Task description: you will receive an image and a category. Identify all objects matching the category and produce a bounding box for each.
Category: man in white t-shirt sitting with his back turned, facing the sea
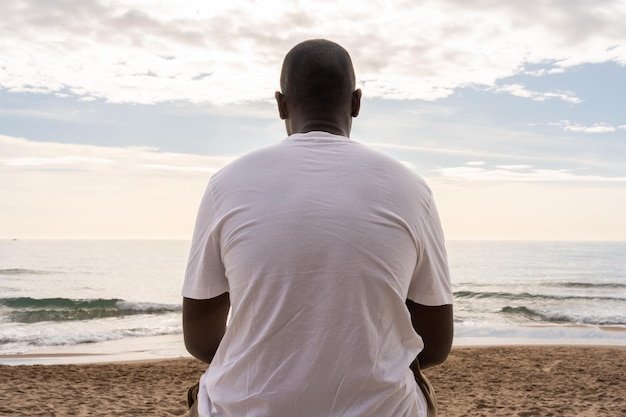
[183,40,452,417]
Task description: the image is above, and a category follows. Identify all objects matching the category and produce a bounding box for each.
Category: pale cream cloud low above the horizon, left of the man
[0,135,233,238]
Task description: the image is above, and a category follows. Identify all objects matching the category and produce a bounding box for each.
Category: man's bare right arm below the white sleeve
[406,300,454,369]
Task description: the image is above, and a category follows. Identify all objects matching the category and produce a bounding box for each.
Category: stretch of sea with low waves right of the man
[448,241,626,344]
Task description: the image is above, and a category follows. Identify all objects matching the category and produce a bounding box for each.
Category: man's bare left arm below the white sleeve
[183,293,230,363]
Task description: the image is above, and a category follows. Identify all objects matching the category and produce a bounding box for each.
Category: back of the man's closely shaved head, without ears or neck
[280,39,355,112]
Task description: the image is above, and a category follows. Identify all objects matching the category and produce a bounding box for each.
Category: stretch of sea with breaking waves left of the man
[0,239,189,363]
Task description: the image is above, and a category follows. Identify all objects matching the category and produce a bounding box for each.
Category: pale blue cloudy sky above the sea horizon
[0,0,626,240]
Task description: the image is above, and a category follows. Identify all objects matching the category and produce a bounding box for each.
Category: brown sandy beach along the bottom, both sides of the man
[0,346,626,417]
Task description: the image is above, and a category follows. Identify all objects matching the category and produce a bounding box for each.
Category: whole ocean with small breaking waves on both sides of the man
[0,239,626,364]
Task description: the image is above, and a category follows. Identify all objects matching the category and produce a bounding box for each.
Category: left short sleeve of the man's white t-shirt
[182,185,229,300]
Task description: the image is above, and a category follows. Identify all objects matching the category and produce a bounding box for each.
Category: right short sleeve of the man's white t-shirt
[407,201,453,306]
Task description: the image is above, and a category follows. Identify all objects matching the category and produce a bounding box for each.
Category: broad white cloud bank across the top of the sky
[0,0,626,104]
